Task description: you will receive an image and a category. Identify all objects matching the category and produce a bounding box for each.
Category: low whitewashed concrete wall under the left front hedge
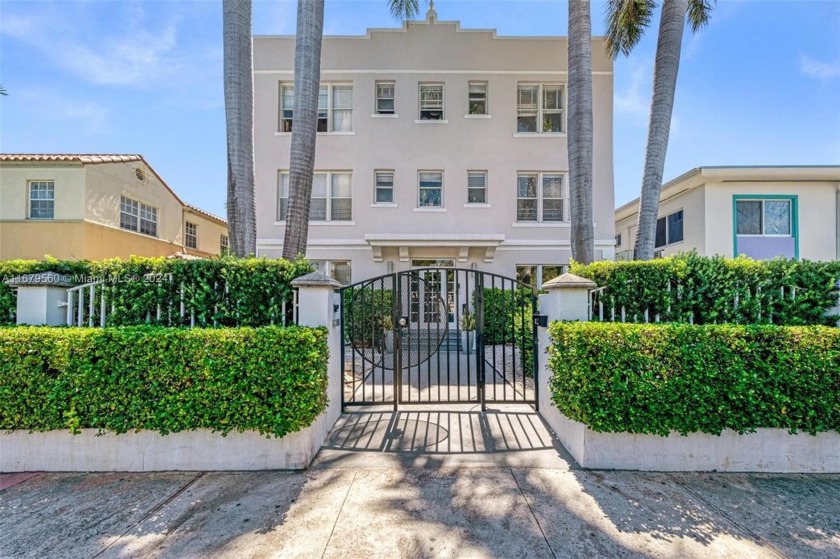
[0,406,338,472]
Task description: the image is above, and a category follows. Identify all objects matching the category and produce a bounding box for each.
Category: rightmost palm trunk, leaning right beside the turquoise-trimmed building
[634,0,688,260]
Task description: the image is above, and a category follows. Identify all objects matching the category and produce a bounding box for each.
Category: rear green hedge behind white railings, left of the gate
[0,257,312,326]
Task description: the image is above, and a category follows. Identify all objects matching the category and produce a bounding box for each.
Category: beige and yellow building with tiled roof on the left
[0,154,228,260]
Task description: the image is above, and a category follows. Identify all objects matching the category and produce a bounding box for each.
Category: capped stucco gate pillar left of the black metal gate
[292,272,344,424]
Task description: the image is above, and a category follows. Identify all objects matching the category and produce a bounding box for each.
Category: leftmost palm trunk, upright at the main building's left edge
[222,0,257,257]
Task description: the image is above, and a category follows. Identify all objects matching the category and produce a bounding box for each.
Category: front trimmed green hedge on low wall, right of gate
[549,322,840,436]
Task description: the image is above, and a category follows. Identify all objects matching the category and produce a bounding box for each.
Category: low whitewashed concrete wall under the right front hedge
[539,328,840,473]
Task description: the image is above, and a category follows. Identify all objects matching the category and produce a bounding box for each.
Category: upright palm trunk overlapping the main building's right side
[568,0,595,264]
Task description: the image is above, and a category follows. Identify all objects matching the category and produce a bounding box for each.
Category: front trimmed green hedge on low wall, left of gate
[0,326,327,437]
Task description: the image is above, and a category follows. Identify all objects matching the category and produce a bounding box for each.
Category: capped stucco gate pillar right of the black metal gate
[537,274,598,434]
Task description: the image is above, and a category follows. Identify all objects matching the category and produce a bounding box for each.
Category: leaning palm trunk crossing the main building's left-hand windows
[283,0,324,258]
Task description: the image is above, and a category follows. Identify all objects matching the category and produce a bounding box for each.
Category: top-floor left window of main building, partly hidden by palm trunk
[280,83,353,132]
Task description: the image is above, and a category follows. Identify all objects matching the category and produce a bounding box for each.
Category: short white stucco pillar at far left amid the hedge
[6,272,73,326]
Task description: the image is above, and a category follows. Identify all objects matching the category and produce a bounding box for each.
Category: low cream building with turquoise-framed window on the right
[615,166,840,260]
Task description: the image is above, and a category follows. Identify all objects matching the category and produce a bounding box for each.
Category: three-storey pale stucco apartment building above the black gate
[254,11,614,283]
